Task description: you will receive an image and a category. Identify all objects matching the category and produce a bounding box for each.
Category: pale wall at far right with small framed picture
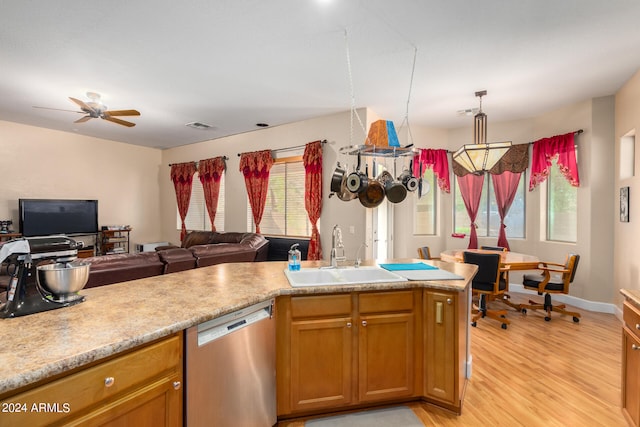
[611,71,640,307]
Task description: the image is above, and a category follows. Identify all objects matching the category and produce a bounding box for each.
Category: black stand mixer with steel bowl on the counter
[0,236,90,318]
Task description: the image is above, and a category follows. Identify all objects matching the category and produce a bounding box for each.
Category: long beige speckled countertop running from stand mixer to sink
[0,259,476,394]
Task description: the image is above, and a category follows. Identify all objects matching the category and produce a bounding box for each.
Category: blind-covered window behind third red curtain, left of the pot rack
[247,157,311,237]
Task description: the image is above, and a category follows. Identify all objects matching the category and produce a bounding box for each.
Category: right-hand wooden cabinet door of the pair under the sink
[358,313,415,402]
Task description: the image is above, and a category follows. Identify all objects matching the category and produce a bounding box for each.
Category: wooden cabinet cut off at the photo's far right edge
[622,301,640,426]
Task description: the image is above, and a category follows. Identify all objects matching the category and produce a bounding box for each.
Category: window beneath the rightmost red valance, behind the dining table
[547,161,578,243]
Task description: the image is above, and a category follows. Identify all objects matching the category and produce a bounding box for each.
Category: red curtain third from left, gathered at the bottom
[240,150,273,233]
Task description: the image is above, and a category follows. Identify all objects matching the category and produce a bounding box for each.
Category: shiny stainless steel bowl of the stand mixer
[37,261,91,296]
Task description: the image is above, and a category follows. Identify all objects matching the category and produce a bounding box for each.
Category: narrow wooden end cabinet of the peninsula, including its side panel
[423,290,468,413]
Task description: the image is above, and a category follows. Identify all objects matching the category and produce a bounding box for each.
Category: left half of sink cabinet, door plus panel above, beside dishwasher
[276,294,354,413]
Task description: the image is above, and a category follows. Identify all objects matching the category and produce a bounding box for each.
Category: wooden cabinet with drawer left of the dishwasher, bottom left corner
[0,333,183,427]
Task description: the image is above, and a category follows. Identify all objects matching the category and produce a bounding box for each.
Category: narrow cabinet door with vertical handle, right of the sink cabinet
[424,291,458,404]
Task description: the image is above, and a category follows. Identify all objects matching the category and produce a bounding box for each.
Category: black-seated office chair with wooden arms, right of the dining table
[520,254,580,323]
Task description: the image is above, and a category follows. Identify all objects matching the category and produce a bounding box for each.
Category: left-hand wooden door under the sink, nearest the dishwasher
[291,317,353,411]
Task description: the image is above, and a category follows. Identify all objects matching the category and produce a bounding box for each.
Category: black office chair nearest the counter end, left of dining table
[463,252,511,329]
